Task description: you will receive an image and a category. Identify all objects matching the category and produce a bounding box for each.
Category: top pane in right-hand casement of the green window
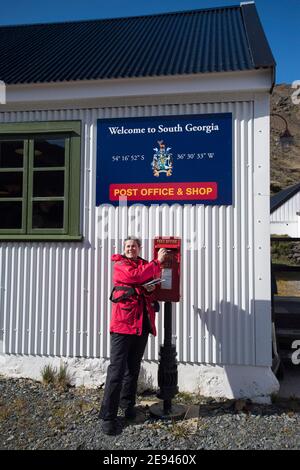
[34,139,65,167]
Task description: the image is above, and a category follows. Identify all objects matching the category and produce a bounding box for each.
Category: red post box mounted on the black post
[154,237,181,302]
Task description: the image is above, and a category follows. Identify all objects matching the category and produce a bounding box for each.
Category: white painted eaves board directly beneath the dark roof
[0,69,272,111]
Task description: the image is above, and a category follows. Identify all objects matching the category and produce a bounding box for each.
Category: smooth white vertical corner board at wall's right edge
[253,95,272,366]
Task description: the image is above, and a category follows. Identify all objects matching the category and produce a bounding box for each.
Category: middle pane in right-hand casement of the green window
[33,171,65,197]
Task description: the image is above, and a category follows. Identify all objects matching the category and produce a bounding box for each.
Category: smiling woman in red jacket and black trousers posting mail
[100,237,167,435]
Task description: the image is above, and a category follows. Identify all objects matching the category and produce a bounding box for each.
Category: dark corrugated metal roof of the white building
[0,5,275,84]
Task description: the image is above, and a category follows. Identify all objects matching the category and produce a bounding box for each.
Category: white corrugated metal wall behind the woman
[0,102,255,364]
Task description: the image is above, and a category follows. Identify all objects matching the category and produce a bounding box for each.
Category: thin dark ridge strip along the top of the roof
[0,5,240,29]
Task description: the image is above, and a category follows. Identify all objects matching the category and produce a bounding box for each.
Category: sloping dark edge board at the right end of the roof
[240,2,276,89]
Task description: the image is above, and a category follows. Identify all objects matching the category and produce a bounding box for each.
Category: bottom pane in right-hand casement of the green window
[32,201,64,228]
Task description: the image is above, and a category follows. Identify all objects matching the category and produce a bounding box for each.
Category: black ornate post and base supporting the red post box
[150,302,186,419]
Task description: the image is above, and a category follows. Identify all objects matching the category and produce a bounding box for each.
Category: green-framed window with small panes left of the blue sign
[0,121,81,240]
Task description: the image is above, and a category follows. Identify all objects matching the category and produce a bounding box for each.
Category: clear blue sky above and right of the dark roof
[0,0,300,83]
